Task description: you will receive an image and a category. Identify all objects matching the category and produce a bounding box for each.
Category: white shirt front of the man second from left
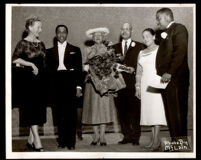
[57,41,67,71]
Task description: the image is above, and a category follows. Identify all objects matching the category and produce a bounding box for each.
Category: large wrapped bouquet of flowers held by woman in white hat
[86,43,133,95]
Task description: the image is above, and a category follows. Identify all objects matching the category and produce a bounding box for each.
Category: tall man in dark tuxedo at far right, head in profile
[156,8,189,137]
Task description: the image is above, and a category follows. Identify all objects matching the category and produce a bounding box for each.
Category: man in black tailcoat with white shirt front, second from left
[46,25,82,150]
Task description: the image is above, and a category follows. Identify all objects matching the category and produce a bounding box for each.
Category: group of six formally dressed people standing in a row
[12,8,189,151]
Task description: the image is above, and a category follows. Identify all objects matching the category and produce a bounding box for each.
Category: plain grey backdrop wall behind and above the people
[11,6,194,128]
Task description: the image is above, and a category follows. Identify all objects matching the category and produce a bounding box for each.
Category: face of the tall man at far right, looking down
[156,12,170,29]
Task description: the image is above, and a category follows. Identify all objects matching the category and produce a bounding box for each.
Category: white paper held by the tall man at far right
[149,75,169,89]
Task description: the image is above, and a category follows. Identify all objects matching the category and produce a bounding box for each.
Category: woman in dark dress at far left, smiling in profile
[12,17,46,152]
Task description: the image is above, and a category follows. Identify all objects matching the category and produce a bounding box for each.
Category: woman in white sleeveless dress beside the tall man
[135,28,167,151]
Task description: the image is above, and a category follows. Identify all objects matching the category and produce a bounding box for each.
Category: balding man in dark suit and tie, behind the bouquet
[113,23,144,145]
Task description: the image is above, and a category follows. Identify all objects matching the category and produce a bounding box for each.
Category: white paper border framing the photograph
[5,3,196,159]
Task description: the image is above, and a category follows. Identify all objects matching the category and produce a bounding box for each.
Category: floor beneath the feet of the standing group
[12,131,192,152]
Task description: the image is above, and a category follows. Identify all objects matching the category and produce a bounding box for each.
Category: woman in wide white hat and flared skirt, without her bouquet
[82,28,117,146]
